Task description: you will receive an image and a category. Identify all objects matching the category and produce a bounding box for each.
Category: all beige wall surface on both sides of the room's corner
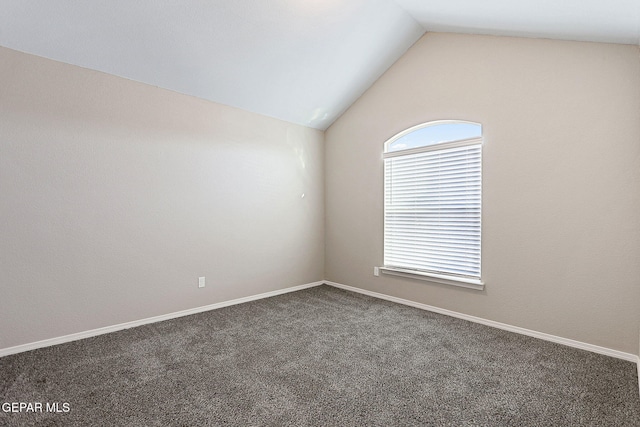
[0,34,640,354]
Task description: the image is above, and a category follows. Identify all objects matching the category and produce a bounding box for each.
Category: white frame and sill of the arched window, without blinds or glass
[380,120,484,290]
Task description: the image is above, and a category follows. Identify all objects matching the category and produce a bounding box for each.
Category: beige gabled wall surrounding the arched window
[325,33,640,354]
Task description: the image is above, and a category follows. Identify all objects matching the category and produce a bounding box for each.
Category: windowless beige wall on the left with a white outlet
[0,48,324,348]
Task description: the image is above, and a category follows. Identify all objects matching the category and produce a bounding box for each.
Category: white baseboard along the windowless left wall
[0,281,325,357]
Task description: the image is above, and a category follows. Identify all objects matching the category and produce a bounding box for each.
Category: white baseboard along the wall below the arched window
[324,280,640,364]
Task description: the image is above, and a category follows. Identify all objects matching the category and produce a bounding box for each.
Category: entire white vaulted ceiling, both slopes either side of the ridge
[0,0,640,129]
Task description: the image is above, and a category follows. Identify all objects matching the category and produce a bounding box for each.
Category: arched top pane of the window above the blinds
[384,120,482,153]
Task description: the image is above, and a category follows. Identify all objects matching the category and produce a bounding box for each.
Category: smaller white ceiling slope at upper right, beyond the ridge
[396,0,640,44]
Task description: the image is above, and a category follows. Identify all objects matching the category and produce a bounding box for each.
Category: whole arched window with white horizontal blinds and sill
[383,120,483,288]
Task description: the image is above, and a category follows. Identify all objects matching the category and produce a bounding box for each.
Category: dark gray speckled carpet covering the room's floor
[0,286,640,426]
